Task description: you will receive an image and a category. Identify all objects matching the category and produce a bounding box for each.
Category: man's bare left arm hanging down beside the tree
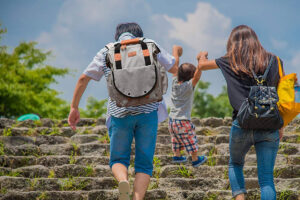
[68,74,91,130]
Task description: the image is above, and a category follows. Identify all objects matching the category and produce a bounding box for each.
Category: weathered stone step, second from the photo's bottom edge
[0,176,300,192]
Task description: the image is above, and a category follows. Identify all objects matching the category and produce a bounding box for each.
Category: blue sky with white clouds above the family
[0,0,300,107]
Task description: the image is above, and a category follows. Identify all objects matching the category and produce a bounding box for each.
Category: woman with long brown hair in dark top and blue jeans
[197,25,283,200]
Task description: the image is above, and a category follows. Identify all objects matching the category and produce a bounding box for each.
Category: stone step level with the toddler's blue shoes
[0,154,300,169]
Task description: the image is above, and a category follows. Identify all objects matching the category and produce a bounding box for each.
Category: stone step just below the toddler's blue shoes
[0,164,300,179]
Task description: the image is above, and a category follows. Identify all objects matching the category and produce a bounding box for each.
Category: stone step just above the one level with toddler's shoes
[3,142,300,156]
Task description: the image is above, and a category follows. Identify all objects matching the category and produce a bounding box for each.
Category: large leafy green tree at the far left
[0,24,69,118]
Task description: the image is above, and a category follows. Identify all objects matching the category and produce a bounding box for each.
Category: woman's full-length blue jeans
[228,120,279,200]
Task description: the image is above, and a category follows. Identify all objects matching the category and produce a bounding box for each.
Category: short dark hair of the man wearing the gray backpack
[115,22,144,41]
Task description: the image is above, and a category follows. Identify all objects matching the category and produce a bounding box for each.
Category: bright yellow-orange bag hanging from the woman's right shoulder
[277,56,300,126]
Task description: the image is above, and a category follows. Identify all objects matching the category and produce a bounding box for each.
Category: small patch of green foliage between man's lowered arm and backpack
[80,97,107,118]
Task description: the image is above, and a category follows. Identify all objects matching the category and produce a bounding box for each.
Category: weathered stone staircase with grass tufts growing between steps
[0,118,300,200]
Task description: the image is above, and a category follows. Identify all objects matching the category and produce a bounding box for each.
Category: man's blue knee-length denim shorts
[109,111,158,176]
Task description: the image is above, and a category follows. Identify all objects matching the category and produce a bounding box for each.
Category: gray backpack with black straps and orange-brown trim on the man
[106,38,168,107]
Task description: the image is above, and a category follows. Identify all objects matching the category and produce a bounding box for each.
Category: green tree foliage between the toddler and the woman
[192,81,232,118]
